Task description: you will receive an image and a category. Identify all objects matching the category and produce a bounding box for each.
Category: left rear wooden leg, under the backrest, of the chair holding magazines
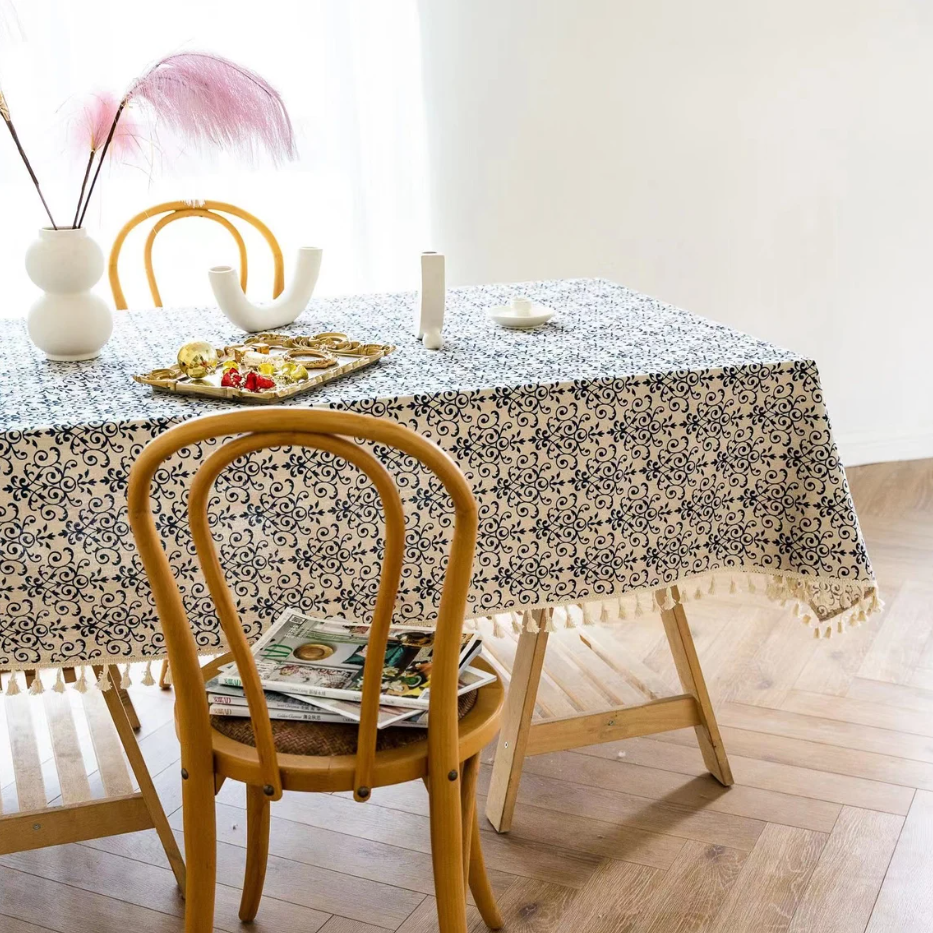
[181,759,217,933]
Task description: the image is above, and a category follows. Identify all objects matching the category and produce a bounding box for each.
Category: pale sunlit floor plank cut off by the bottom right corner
[866,791,933,933]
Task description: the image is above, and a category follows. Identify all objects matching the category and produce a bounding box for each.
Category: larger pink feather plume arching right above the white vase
[123,52,296,162]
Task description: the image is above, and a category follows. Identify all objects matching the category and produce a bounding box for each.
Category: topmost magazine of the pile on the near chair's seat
[212,609,495,727]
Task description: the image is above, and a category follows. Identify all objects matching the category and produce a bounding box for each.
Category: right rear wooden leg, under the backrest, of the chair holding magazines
[427,772,467,933]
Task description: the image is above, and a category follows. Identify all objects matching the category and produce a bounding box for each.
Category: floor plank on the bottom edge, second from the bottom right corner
[789,807,904,933]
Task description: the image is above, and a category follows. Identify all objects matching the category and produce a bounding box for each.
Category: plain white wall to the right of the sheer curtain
[420,0,933,465]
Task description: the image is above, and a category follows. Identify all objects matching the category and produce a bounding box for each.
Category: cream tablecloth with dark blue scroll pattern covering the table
[0,280,874,668]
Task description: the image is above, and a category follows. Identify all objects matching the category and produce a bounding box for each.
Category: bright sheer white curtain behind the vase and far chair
[0,0,431,317]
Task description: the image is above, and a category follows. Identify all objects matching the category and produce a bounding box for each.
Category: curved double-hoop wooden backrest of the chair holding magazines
[128,408,477,800]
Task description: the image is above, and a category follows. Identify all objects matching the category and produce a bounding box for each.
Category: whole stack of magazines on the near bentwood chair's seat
[207,609,495,729]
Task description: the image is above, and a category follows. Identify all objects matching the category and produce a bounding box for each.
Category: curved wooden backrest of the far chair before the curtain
[108,201,285,311]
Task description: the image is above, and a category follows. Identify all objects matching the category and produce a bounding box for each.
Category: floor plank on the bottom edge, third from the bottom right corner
[708,824,827,933]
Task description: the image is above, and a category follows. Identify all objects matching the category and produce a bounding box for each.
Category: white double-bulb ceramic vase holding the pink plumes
[26,227,113,360]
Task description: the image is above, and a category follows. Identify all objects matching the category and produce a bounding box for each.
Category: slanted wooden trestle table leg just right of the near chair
[486,609,551,833]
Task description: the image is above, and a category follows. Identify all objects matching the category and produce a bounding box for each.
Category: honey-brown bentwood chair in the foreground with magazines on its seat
[128,408,503,933]
